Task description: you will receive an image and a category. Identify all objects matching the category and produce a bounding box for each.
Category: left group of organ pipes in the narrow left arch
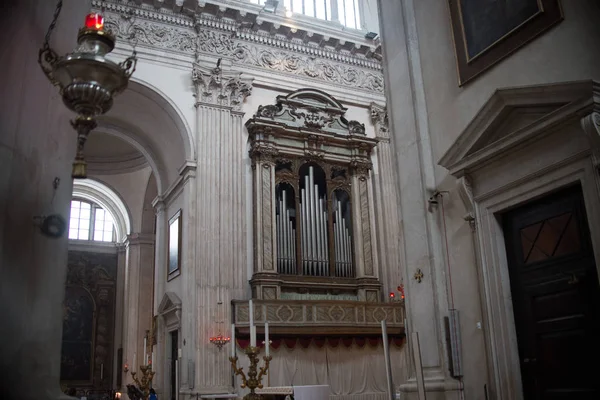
[275,189,298,275]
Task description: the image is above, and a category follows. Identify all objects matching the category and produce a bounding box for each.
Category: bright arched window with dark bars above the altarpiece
[69,199,116,242]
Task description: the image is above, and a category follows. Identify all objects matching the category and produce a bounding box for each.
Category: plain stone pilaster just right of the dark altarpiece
[123,233,154,386]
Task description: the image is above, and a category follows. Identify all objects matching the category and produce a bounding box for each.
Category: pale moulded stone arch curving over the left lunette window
[73,178,131,243]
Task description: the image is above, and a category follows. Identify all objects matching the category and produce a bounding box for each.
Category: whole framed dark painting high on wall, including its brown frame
[448,0,563,86]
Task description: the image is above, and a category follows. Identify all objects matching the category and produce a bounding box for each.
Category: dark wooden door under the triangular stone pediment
[503,186,600,400]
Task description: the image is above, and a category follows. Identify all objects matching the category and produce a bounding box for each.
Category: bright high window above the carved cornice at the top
[250,0,361,29]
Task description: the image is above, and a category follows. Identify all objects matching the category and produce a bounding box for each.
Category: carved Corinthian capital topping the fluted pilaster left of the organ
[192,63,253,111]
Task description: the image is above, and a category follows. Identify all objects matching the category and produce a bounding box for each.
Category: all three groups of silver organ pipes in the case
[275,166,354,278]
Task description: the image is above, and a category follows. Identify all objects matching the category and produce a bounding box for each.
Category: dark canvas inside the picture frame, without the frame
[460,0,541,59]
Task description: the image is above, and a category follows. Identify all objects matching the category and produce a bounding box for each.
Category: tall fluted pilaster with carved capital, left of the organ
[192,61,252,398]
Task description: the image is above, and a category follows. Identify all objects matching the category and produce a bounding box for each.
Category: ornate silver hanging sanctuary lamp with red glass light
[38,0,137,179]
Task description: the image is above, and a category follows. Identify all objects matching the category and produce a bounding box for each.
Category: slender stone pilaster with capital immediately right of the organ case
[370,103,404,294]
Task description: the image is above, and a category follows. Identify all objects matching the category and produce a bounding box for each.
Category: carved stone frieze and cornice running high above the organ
[92,1,384,95]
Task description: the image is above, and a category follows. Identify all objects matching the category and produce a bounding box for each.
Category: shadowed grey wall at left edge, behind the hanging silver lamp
[0,0,90,400]
